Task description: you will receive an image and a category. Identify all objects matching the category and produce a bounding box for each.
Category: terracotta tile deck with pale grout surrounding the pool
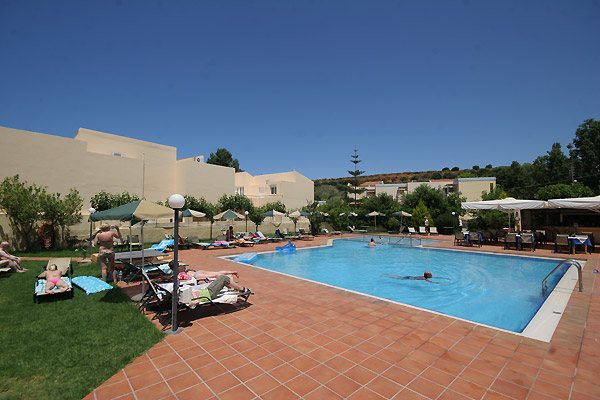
[86,236,600,400]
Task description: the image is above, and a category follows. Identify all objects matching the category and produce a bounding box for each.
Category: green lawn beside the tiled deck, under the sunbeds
[0,258,164,399]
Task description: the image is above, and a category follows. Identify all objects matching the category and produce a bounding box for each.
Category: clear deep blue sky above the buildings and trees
[0,0,600,179]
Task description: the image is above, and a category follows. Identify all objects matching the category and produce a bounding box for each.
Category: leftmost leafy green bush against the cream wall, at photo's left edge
[0,175,45,250]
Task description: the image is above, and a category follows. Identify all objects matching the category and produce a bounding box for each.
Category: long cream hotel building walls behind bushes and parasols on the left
[0,127,314,240]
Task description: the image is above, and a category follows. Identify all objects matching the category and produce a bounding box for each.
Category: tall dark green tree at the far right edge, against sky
[569,119,600,191]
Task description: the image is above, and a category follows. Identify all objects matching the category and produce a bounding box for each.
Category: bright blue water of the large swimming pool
[232,240,568,332]
